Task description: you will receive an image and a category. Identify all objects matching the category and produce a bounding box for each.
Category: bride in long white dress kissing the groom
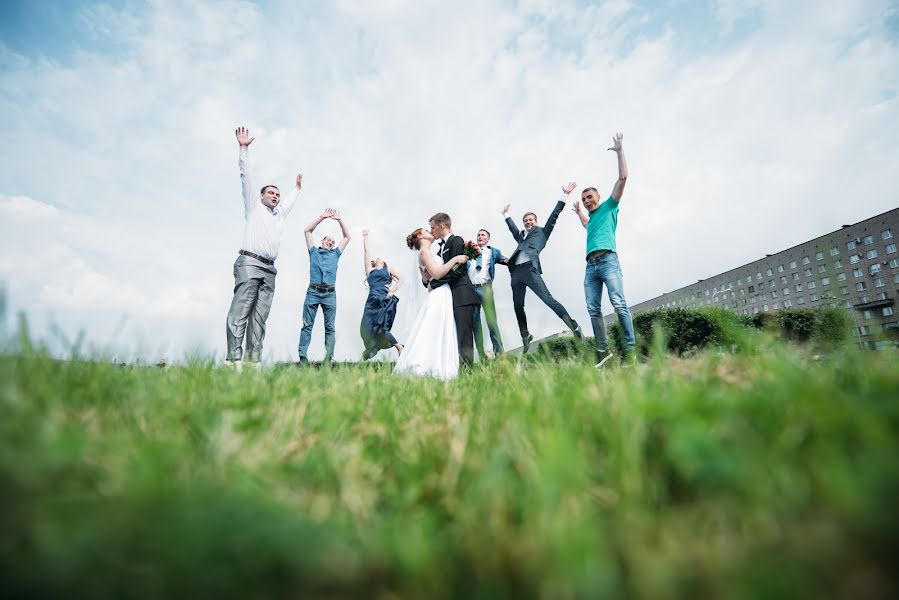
[393,227,468,380]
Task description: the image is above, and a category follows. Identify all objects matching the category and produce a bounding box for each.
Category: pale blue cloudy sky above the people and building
[0,0,899,362]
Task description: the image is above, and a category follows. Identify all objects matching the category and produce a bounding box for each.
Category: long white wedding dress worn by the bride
[393,255,459,381]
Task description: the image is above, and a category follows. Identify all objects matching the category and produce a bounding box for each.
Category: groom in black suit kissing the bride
[428,213,481,366]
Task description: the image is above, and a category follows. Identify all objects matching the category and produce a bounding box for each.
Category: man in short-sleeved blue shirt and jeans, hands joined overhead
[298,208,350,364]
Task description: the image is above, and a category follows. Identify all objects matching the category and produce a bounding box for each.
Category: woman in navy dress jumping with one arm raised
[359,229,403,360]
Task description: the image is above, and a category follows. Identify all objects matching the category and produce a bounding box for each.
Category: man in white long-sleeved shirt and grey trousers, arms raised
[226,127,303,367]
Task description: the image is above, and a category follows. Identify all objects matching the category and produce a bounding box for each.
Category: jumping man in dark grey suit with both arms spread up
[503,181,584,352]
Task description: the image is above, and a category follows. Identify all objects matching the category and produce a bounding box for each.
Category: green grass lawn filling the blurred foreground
[0,342,899,599]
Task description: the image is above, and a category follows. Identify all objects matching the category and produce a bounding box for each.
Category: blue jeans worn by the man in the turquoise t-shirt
[584,252,635,352]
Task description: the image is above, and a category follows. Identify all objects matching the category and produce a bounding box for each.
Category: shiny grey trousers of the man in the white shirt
[225,254,278,362]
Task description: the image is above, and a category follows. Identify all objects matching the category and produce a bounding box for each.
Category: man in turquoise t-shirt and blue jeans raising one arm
[572,133,635,369]
